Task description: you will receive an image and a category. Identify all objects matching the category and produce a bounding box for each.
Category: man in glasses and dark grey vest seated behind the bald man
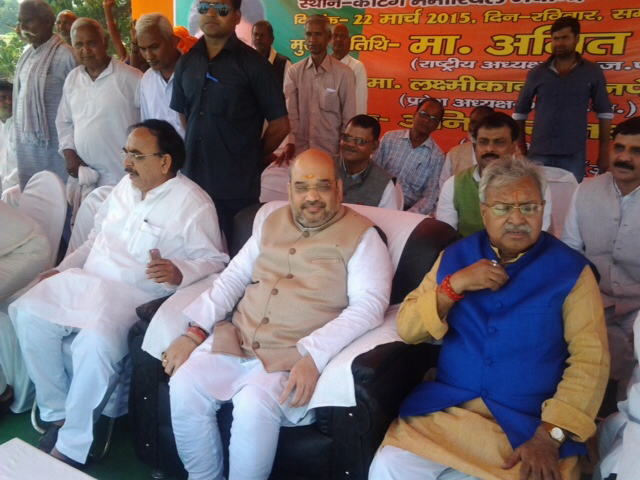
[338,115,404,210]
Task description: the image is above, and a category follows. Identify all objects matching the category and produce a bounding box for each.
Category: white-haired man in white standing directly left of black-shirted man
[136,13,184,138]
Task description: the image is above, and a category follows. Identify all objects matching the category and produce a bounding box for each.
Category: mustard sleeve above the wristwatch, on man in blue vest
[542,266,609,442]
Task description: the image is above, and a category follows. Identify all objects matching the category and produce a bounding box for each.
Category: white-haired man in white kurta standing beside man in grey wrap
[56,18,142,191]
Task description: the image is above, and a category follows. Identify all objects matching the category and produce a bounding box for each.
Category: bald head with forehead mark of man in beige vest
[289,149,342,228]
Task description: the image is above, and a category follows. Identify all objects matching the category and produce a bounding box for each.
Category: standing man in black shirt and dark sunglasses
[171,0,289,241]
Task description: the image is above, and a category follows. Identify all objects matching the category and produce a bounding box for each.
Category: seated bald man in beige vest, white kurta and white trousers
[163,150,392,480]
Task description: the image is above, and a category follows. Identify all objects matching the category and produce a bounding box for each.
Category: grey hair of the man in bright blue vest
[478,155,547,203]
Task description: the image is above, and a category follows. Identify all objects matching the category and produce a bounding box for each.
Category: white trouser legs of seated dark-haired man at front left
[14,311,124,463]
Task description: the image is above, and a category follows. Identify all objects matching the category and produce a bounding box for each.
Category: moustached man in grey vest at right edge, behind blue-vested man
[562,117,640,400]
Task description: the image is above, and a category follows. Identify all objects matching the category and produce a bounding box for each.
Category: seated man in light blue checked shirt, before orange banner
[373,98,444,215]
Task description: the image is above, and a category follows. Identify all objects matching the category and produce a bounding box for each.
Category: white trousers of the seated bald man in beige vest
[169,339,296,480]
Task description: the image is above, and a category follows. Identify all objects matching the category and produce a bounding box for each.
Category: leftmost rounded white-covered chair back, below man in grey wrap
[18,170,67,268]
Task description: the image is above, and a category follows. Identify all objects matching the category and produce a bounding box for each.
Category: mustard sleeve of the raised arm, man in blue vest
[396,252,449,343]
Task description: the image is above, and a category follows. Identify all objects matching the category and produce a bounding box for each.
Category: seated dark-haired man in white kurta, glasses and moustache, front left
[9,120,228,465]
